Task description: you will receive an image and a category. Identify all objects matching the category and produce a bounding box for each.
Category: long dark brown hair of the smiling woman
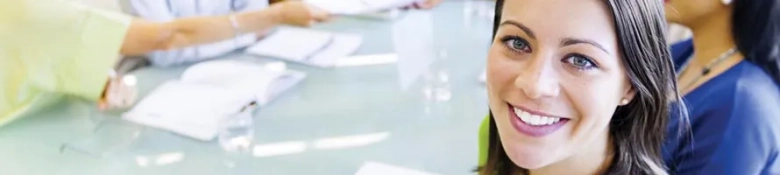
[480,0,687,175]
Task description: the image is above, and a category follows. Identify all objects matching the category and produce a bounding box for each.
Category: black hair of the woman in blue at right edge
[731,0,780,83]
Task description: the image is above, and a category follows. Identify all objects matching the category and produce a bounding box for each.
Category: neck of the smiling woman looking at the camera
[529,133,615,175]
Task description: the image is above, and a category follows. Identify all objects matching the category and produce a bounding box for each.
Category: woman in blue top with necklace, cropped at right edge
[663,0,780,175]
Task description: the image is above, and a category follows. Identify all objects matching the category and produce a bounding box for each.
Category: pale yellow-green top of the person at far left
[0,0,131,126]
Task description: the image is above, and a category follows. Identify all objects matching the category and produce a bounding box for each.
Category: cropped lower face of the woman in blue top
[664,0,727,26]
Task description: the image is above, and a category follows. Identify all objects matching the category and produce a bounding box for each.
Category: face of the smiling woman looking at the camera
[487,0,633,169]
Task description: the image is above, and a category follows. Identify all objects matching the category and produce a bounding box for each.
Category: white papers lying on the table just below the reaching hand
[245,27,363,67]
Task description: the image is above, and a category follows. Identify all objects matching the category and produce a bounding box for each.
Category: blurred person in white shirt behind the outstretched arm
[129,0,328,66]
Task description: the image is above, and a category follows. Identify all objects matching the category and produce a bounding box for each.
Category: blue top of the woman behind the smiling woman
[663,40,780,175]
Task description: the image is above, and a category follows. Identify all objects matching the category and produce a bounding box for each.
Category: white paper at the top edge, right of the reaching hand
[304,0,421,15]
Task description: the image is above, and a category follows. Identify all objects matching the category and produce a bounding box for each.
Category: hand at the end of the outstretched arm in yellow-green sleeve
[271,1,330,26]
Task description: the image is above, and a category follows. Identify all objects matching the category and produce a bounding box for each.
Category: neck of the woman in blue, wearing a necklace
[686,7,736,66]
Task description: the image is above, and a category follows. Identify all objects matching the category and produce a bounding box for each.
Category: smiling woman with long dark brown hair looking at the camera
[481,0,685,175]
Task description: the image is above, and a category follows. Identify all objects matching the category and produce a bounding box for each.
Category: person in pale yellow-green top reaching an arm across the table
[0,0,326,125]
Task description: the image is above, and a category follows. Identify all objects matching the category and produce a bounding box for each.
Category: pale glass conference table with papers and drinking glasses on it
[0,1,493,175]
